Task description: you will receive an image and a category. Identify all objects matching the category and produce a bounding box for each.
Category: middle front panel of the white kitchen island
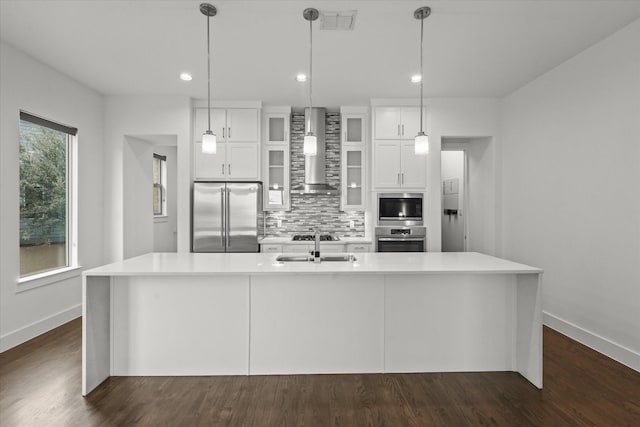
[250,274,384,375]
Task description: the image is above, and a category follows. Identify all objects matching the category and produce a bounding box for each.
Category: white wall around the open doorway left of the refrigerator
[104,95,192,262]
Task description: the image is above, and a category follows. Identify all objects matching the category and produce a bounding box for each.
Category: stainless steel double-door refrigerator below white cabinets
[191,182,263,252]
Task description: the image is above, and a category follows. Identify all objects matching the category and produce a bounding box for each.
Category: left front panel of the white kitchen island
[113,275,250,376]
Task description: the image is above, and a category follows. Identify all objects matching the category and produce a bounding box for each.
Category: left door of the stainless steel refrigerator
[192,182,225,252]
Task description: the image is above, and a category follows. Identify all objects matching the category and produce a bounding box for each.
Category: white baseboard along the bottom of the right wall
[542,311,640,372]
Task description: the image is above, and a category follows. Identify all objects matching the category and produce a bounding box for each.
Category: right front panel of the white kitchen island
[385,274,515,372]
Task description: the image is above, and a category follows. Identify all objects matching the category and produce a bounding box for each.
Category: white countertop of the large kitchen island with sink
[83,252,542,276]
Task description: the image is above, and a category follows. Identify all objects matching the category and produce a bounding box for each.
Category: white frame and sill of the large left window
[16,110,82,292]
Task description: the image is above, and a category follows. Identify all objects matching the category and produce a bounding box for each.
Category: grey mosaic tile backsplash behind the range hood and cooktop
[265,112,364,237]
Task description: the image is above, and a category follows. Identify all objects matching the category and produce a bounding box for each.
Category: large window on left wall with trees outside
[20,111,78,278]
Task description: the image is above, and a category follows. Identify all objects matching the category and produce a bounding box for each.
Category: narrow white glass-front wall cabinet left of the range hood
[262,107,291,210]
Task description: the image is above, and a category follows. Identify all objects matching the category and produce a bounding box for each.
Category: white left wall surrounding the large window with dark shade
[0,43,104,351]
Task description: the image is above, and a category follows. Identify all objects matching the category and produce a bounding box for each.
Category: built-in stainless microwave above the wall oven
[378,193,424,226]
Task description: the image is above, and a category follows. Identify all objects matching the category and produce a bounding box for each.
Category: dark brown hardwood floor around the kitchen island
[0,319,640,427]
